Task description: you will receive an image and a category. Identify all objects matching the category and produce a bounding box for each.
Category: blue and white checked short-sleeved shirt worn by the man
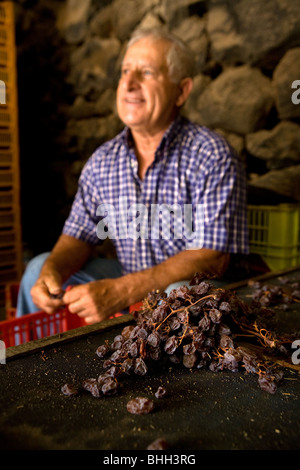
[63,117,248,273]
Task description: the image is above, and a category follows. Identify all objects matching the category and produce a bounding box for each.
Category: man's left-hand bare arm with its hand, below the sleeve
[31,235,92,313]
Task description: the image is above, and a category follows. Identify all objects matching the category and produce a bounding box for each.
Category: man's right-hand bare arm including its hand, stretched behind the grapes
[63,248,230,323]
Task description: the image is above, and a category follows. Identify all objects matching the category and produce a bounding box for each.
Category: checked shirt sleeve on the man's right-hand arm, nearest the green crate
[189,133,249,254]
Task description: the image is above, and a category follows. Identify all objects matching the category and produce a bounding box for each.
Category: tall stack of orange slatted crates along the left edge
[0,1,22,307]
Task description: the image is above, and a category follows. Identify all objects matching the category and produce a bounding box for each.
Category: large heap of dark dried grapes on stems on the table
[63,274,293,397]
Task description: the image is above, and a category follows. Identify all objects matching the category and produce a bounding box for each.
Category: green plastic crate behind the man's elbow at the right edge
[248,204,300,271]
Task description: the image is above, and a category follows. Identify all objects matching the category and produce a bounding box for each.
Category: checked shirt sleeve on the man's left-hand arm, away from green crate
[63,160,101,245]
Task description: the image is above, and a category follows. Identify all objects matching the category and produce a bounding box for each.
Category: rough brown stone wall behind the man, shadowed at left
[16,0,300,252]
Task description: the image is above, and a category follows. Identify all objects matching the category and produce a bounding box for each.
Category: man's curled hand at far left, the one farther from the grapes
[31,274,64,313]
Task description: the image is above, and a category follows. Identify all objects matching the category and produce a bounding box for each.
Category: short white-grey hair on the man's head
[126,28,195,83]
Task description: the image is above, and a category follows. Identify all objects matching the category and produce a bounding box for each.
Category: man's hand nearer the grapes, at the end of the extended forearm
[63,278,128,324]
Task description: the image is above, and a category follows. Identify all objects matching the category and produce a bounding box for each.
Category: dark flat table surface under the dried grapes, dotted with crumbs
[0,270,300,452]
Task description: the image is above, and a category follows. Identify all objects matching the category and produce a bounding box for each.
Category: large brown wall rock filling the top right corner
[208,0,300,69]
